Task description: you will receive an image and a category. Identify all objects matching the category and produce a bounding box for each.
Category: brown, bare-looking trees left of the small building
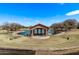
[0,23,25,32]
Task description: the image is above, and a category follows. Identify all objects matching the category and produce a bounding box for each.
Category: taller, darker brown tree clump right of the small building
[50,19,79,34]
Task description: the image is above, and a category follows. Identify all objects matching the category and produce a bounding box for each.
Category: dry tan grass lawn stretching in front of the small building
[0,30,79,50]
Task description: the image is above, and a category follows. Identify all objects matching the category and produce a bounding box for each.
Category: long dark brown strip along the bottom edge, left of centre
[0,50,35,55]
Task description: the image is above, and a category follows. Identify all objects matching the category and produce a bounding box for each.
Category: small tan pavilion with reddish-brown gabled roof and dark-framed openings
[30,24,49,36]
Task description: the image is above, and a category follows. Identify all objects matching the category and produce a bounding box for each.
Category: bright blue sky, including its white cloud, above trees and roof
[0,3,79,26]
